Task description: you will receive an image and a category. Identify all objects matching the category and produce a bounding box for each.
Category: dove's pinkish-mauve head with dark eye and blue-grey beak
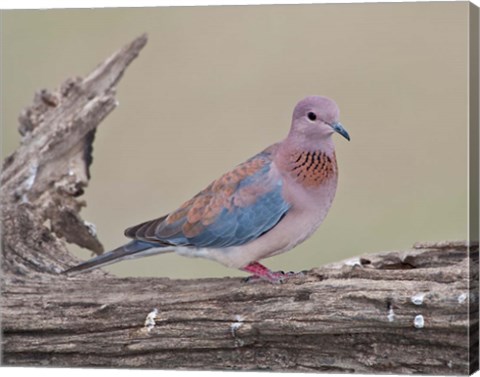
[290,96,350,143]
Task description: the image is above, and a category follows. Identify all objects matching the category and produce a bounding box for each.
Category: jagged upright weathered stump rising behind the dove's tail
[1,35,147,273]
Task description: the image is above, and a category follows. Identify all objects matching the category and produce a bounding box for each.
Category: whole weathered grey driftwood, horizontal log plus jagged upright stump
[1,36,478,374]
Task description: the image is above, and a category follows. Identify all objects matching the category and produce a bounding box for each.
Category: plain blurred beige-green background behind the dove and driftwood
[1,2,468,278]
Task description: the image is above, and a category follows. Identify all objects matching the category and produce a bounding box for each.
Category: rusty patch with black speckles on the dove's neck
[290,151,337,187]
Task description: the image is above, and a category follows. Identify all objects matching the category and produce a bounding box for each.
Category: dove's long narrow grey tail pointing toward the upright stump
[62,240,173,274]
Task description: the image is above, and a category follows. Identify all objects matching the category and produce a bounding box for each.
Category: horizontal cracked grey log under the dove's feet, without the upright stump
[2,239,478,374]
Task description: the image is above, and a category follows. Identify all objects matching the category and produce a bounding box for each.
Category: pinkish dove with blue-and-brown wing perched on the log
[64,96,350,283]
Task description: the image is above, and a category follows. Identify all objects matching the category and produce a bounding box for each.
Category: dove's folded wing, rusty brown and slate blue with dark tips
[125,145,290,248]
